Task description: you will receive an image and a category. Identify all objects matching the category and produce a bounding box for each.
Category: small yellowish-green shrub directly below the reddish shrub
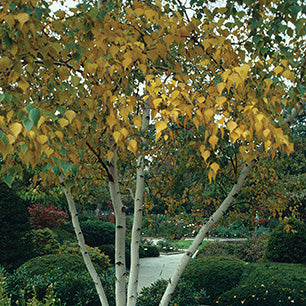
[28,228,60,257]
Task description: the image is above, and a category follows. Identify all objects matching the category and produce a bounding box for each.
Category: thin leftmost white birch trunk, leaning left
[60,176,109,306]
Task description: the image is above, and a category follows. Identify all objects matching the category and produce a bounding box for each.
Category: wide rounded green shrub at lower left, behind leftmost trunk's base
[7,254,114,305]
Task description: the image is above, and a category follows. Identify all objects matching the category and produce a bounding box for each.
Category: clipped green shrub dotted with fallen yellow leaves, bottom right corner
[218,263,306,306]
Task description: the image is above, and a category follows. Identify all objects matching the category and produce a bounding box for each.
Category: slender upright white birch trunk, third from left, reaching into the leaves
[127,101,150,306]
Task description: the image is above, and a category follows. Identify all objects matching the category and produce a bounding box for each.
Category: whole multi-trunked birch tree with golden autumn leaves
[0,0,305,306]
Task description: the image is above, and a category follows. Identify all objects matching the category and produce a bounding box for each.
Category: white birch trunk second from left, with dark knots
[109,149,126,306]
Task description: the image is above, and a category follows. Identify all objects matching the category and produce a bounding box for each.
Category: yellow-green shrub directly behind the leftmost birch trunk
[57,241,110,271]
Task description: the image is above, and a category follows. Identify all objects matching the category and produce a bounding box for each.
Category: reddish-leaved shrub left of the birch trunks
[28,203,67,229]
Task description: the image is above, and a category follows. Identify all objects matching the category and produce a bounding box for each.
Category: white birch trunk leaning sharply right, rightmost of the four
[159,161,254,306]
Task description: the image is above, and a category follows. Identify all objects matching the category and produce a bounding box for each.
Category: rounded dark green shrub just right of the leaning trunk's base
[182,256,246,301]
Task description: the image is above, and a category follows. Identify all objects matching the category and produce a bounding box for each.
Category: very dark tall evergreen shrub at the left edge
[0,182,31,270]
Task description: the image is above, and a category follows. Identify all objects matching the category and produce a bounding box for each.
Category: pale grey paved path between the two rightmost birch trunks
[137,254,183,292]
